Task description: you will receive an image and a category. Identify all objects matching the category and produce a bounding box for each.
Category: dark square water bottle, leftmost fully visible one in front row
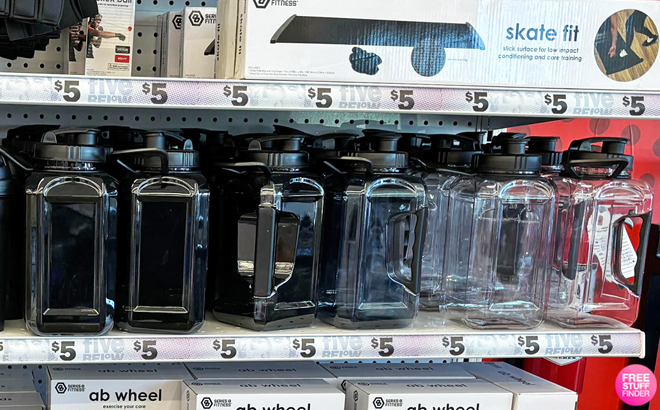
[25,129,117,336]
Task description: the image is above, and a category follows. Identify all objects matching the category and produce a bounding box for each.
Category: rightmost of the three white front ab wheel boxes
[344,379,512,410]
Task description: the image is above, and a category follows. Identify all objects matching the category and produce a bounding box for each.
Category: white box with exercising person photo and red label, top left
[85,0,135,77]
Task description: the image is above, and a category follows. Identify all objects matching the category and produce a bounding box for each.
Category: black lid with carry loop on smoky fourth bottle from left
[344,130,408,169]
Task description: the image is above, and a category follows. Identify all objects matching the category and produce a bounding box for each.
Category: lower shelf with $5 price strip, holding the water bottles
[0,313,644,364]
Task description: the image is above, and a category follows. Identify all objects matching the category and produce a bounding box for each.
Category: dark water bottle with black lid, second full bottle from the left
[113,131,209,333]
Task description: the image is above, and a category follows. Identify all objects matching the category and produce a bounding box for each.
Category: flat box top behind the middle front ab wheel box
[186,362,335,382]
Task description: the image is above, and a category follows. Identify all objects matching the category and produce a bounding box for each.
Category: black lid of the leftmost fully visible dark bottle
[34,128,107,164]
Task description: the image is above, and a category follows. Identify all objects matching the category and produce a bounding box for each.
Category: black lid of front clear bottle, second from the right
[473,133,541,174]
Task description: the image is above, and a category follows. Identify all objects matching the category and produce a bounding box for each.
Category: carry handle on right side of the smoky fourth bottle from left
[388,208,427,294]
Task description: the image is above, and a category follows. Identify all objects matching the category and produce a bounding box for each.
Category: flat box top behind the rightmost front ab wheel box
[321,363,475,390]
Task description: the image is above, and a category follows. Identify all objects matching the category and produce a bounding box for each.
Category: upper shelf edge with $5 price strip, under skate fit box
[0,74,660,119]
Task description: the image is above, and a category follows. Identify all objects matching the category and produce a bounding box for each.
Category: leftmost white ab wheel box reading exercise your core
[48,363,190,410]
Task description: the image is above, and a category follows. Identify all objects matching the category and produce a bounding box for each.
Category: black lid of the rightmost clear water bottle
[564,137,633,171]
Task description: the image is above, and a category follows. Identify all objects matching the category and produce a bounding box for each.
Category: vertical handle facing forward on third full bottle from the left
[254,204,277,298]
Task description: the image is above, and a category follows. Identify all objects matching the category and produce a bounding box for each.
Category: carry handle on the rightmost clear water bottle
[612,212,652,296]
